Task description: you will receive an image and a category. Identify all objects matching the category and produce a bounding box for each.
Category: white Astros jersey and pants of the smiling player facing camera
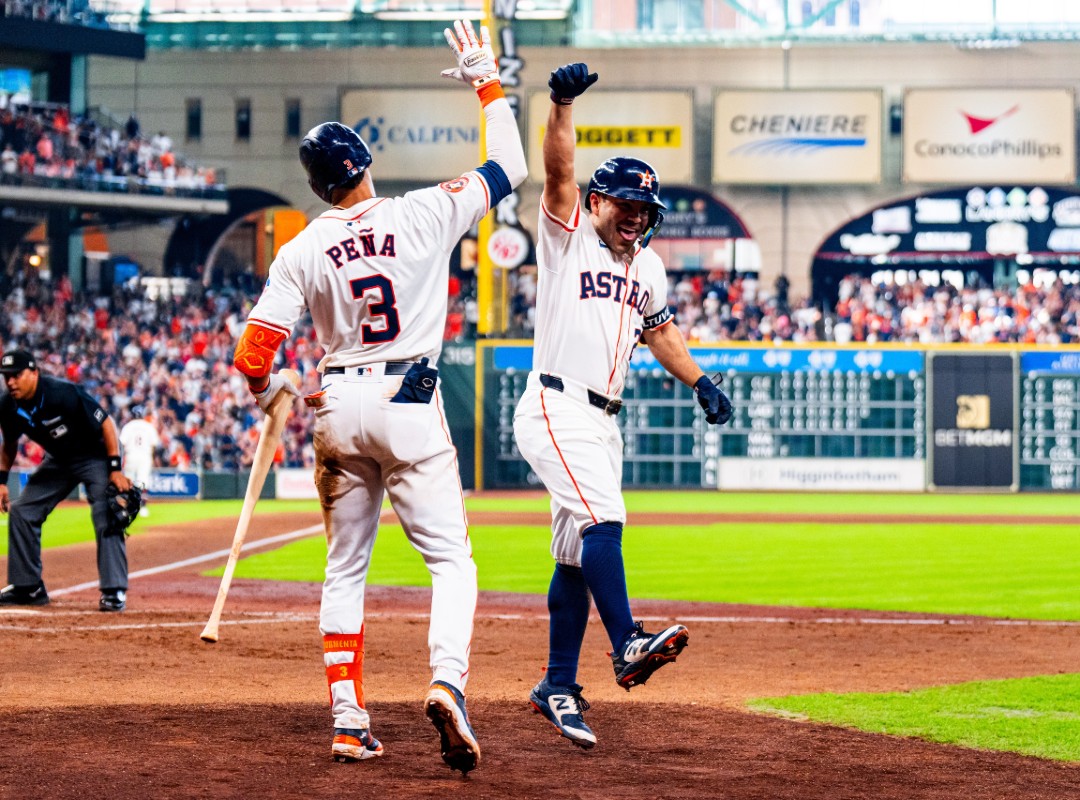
[514,198,672,567]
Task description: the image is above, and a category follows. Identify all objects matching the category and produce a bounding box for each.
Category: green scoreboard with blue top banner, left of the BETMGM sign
[483,344,927,488]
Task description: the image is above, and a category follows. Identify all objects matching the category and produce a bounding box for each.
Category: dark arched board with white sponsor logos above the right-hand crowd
[810,185,1080,308]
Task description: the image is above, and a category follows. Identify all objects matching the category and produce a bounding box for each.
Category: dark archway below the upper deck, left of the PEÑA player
[164,188,289,289]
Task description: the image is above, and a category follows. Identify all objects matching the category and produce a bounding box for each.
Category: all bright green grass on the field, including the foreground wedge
[14,485,1080,761]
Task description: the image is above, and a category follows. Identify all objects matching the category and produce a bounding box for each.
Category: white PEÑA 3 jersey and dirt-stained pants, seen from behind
[241,93,526,729]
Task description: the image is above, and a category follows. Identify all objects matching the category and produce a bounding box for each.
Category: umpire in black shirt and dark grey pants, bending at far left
[0,350,138,611]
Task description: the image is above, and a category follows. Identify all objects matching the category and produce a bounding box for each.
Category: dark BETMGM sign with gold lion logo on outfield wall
[927,352,1020,491]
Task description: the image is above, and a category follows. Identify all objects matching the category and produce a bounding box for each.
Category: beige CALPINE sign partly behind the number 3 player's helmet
[340,87,480,181]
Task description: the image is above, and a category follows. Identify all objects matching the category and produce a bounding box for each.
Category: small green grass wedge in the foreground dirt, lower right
[750,675,1080,761]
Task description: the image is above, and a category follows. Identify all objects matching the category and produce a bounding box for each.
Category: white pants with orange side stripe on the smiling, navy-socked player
[514,374,626,567]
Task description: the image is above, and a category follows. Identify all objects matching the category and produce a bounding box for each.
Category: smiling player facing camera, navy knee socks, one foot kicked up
[514,64,731,748]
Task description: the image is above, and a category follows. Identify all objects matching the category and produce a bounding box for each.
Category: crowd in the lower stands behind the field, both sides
[0,262,1080,470]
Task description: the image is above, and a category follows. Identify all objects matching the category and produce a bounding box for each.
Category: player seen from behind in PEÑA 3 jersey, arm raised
[234,21,527,773]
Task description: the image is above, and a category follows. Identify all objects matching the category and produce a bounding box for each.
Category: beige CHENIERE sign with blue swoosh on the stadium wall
[713,91,882,185]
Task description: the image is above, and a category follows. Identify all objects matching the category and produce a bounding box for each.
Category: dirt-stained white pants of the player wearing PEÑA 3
[314,364,476,728]
